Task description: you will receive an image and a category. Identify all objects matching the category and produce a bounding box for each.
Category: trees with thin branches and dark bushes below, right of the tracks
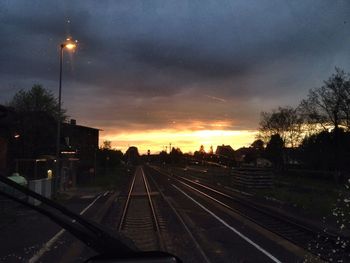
[259,68,350,171]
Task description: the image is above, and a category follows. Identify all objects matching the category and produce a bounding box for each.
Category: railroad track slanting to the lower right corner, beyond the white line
[151,167,350,262]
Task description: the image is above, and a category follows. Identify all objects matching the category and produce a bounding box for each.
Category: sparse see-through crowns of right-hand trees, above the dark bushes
[259,68,350,147]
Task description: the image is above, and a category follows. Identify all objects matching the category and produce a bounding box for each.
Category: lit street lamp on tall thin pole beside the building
[55,38,78,194]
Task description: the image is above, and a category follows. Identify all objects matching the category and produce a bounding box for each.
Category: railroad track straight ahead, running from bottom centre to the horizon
[118,166,164,251]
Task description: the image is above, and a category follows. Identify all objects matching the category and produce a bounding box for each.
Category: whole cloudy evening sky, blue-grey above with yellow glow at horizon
[0,0,350,152]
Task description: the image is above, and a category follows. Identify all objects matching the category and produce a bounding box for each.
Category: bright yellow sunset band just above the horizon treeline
[100,129,257,154]
